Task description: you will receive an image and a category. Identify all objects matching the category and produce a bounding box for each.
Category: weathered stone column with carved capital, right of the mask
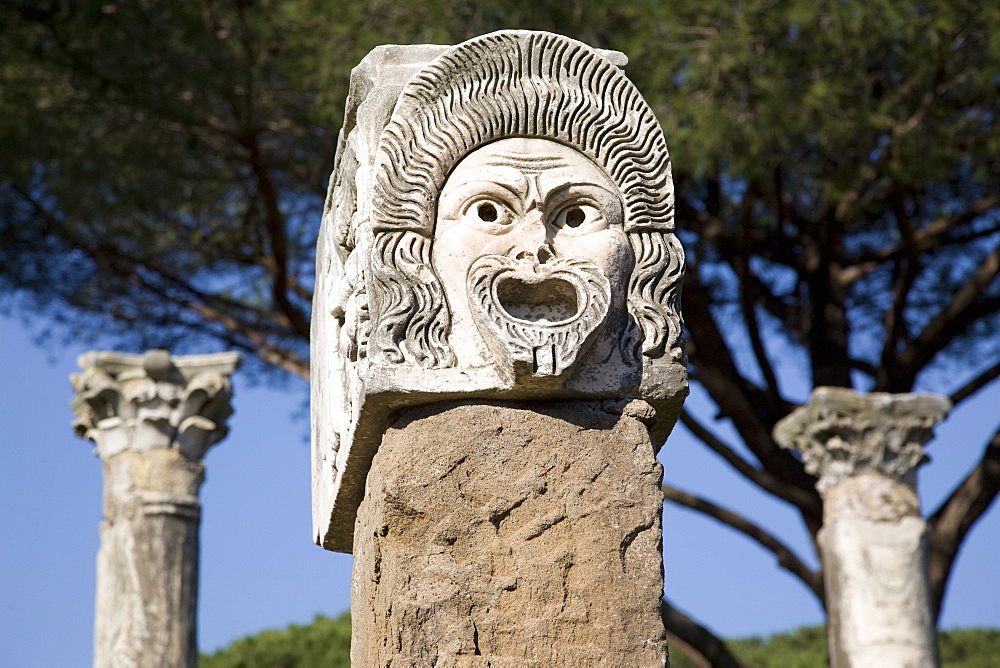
[774,387,951,668]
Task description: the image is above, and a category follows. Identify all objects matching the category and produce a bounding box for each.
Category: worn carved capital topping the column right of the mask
[774,387,951,493]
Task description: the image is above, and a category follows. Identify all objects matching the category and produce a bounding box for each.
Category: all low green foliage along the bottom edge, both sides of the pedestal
[201,612,1000,668]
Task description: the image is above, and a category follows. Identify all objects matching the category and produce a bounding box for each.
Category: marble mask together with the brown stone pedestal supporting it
[312,31,687,666]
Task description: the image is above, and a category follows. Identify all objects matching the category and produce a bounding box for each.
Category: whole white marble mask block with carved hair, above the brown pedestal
[312,31,687,551]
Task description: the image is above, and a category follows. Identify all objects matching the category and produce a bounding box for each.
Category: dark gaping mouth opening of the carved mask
[495,275,580,325]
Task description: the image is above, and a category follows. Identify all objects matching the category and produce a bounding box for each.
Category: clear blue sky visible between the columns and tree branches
[0,317,1000,668]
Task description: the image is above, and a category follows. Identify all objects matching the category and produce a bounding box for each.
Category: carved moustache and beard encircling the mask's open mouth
[466,254,611,385]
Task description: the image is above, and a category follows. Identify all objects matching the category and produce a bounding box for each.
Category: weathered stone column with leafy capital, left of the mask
[71,350,240,668]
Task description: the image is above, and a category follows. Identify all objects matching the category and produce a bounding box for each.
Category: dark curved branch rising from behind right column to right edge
[928,429,1000,617]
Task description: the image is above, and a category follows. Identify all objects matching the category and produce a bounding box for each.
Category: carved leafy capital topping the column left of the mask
[70,350,241,460]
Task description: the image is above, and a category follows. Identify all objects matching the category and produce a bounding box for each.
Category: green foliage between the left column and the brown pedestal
[200,612,351,668]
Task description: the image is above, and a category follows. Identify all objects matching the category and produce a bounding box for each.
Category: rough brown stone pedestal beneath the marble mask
[351,401,666,666]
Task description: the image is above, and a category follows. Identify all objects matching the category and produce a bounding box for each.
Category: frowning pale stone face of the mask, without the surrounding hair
[431,138,634,385]
